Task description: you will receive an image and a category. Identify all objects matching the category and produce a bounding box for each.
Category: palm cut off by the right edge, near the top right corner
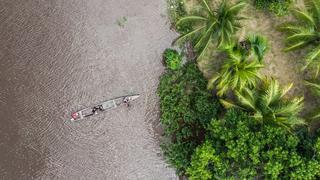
[280,0,320,76]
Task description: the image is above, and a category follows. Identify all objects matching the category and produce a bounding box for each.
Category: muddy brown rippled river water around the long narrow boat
[0,0,176,180]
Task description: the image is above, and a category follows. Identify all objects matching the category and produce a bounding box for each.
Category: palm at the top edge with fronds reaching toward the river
[174,0,246,58]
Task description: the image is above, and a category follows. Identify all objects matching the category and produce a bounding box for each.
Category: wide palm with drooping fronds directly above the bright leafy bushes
[221,78,305,129]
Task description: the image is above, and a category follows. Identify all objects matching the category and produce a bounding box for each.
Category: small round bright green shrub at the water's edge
[163,49,182,70]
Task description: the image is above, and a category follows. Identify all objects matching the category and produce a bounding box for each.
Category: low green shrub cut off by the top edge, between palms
[254,0,292,16]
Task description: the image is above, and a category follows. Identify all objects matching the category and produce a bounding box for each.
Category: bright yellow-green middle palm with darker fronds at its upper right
[208,35,267,96]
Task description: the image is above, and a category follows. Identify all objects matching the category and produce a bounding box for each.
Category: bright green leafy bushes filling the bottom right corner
[187,109,320,180]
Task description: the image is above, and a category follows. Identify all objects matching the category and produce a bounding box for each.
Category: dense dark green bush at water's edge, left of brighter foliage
[158,63,219,174]
